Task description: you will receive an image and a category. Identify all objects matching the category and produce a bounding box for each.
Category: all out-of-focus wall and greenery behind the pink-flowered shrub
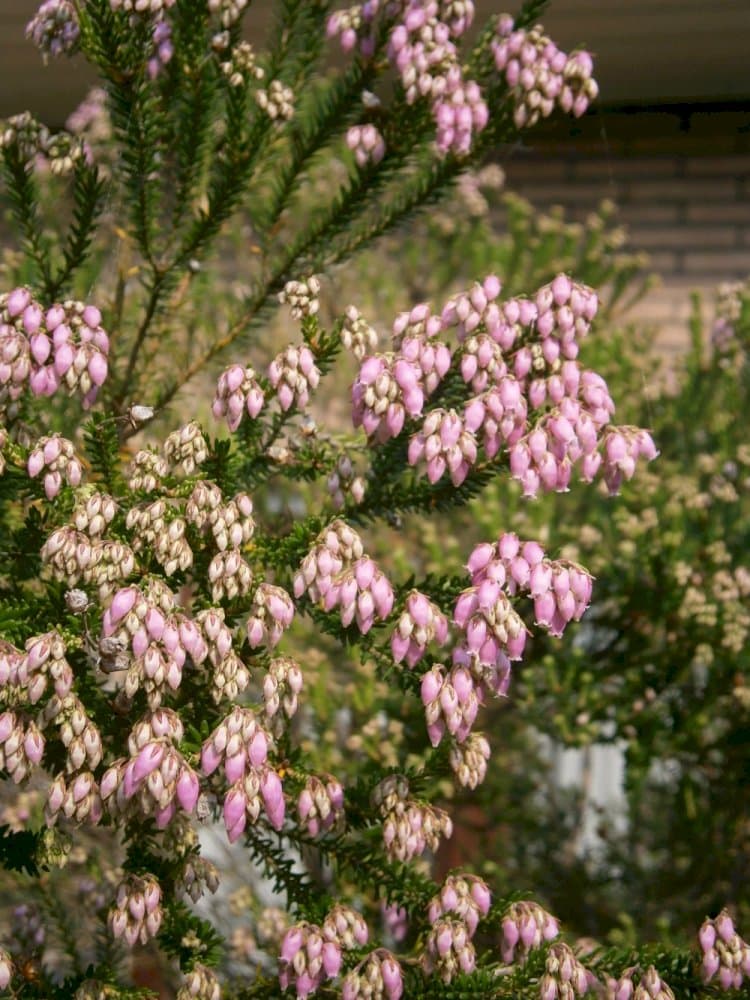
[0,0,750,997]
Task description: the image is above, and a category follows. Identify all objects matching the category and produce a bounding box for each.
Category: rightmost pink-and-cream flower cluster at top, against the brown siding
[492,14,599,128]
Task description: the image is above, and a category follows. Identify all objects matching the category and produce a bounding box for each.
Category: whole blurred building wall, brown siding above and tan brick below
[0,0,750,350]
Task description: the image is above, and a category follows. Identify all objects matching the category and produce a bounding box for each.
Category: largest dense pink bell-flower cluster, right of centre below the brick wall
[352,274,657,497]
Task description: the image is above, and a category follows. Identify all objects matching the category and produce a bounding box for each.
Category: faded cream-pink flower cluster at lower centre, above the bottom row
[372,775,453,861]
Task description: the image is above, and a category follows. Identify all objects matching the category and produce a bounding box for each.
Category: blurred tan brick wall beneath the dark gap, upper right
[504,106,750,349]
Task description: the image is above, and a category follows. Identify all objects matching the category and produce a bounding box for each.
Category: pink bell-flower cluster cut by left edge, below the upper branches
[0,287,109,407]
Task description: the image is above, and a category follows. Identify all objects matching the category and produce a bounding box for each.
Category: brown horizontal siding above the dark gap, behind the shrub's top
[0,0,750,124]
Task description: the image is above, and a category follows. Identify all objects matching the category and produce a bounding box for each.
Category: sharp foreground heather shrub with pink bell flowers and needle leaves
[0,0,748,1000]
